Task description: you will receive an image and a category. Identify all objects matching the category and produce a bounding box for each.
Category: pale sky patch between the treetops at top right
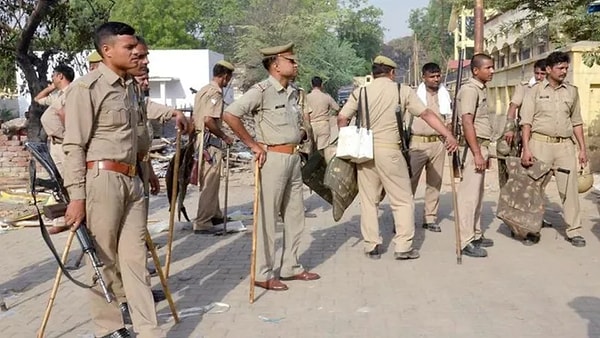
[368,0,429,42]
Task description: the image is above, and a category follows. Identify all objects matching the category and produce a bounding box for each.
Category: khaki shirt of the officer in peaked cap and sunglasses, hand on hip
[227,76,303,145]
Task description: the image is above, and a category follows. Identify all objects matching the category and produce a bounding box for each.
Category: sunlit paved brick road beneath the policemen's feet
[0,162,600,337]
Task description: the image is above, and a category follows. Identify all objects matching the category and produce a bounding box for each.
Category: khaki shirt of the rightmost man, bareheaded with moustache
[521,80,583,138]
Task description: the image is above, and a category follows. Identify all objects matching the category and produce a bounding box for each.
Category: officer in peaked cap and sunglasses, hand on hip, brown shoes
[223,43,320,291]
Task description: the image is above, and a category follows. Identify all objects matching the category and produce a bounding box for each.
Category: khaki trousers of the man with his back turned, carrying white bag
[356,147,415,252]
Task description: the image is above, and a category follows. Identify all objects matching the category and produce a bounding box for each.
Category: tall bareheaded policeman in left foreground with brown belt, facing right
[63,22,165,337]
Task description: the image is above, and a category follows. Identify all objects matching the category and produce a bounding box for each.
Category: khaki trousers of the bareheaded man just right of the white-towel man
[457,145,489,249]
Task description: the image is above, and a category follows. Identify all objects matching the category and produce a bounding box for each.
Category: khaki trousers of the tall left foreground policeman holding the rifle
[86,166,165,338]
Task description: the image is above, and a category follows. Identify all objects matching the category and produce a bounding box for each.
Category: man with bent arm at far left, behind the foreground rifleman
[34,65,75,173]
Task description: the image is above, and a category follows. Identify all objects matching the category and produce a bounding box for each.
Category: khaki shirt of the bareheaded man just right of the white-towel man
[456,78,493,140]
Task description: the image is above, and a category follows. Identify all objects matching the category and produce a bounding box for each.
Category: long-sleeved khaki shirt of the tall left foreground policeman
[63,63,143,200]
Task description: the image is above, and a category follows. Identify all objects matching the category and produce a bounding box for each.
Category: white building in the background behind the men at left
[17,49,233,116]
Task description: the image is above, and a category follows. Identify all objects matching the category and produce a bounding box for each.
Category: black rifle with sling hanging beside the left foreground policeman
[25,142,112,303]
